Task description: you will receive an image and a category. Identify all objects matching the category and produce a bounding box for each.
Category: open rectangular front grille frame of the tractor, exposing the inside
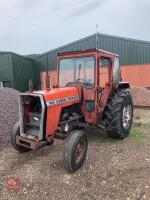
[20,94,45,140]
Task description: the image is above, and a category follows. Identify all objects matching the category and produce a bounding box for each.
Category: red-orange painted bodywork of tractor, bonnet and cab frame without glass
[35,49,124,138]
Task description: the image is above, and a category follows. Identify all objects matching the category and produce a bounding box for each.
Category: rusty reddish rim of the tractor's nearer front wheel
[74,141,85,164]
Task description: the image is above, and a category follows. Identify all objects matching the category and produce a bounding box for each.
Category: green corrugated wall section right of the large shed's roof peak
[98,34,150,65]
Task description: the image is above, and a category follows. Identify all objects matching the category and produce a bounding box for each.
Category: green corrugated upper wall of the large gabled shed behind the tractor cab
[33,34,150,88]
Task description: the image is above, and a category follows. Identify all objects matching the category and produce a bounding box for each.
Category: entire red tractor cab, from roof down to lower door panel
[57,49,129,124]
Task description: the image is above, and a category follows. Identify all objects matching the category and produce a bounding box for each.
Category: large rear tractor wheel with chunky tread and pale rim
[104,90,133,139]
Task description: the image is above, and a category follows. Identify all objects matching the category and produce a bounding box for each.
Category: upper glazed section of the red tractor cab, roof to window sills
[57,49,121,88]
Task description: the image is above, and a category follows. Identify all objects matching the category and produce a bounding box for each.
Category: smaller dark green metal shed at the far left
[0,52,34,92]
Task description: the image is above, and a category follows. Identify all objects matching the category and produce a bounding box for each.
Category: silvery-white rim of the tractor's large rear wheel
[122,104,132,129]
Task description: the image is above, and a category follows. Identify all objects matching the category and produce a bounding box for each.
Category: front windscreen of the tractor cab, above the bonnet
[59,57,95,87]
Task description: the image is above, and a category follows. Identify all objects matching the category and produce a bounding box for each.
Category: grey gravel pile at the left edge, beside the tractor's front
[0,88,19,149]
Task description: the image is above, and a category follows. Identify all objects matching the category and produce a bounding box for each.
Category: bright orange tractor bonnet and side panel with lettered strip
[43,87,80,138]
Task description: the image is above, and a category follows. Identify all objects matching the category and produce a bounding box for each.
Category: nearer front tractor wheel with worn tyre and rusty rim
[63,130,88,173]
